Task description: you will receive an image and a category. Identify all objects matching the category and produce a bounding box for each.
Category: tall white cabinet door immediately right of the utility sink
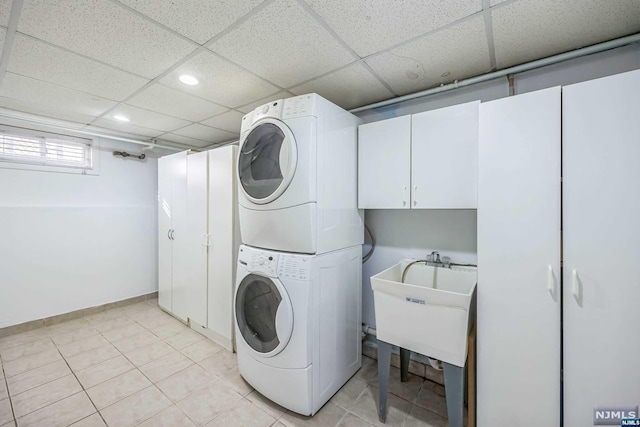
[477,88,561,427]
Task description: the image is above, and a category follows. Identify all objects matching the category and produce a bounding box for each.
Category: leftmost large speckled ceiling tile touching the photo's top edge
[18,0,194,78]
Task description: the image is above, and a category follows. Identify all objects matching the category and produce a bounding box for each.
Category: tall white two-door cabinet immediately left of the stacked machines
[187,145,240,350]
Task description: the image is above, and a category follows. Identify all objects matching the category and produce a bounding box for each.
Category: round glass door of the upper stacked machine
[238,119,297,204]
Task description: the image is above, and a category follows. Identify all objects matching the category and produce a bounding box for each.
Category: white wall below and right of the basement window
[0,140,158,328]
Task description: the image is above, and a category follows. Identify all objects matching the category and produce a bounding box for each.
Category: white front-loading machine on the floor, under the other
[235,245,362,415]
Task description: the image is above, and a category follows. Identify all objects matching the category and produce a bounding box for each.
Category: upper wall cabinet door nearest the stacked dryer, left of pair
[358,116,411,209]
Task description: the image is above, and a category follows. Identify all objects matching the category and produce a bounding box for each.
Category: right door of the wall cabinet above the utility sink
[411,101,480,209]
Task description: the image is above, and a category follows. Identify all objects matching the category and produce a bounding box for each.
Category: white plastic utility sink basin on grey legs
[371,260,478,367]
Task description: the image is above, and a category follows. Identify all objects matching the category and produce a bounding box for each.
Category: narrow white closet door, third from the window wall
[184,151,210,326]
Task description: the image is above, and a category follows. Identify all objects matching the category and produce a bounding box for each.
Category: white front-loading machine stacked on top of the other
[237,94,364,254]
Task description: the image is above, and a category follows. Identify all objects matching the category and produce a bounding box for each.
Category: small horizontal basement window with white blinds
[0,126,97,175]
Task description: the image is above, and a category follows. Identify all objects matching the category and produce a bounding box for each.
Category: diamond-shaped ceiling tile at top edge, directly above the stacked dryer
[209,0,354,87]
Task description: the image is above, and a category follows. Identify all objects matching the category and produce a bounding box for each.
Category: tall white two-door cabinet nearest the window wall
[158,151,188,322]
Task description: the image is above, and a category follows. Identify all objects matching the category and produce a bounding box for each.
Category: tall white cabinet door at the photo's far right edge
[562,71,640,427]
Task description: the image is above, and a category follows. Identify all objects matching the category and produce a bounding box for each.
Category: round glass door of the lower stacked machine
[236,274,293,357]
